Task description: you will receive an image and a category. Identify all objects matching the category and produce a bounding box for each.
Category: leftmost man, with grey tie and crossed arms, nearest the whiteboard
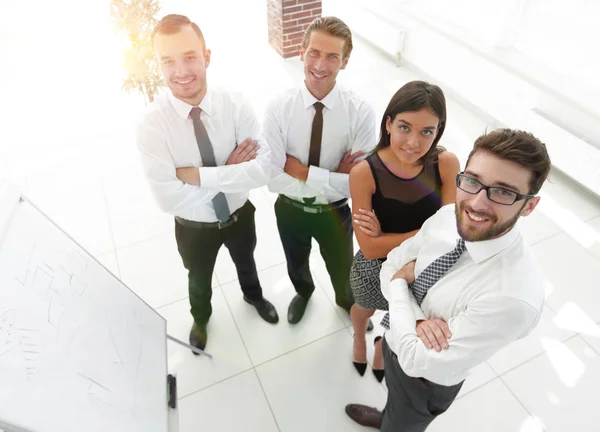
[137,15,279,349]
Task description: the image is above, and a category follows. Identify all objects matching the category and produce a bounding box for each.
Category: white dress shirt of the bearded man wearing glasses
[381,204,544,386]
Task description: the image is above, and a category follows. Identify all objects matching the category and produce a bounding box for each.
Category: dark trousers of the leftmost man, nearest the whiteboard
[175,201,262,325]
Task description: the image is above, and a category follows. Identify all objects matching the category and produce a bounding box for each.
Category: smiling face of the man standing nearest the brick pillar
[300,31,349,100]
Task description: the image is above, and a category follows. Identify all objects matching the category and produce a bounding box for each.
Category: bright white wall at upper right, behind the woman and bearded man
[324,0,600,195]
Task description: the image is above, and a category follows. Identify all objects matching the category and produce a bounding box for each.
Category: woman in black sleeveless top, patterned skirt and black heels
[350,81,460,381]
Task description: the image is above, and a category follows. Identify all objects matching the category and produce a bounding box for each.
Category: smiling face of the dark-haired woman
[386,108,439,165]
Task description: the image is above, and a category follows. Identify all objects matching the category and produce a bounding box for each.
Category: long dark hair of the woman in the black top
[373,81,446,163]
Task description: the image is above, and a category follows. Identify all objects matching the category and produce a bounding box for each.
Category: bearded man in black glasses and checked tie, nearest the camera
[346,129,550,432]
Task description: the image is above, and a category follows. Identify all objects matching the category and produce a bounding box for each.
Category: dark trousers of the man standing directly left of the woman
[275,198,354,310]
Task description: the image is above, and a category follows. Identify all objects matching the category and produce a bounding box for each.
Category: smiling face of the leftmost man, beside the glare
[154,25,210,105]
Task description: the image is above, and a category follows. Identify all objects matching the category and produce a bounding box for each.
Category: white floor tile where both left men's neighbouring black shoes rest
[221,264,344,365]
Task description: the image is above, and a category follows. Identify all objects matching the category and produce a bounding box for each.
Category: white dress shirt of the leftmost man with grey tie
[137,88,273,222]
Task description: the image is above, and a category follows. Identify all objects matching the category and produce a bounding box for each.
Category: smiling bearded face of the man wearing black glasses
[456,151,540,242]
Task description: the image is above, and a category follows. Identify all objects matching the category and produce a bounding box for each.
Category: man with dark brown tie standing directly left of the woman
[264,17,377,324]
